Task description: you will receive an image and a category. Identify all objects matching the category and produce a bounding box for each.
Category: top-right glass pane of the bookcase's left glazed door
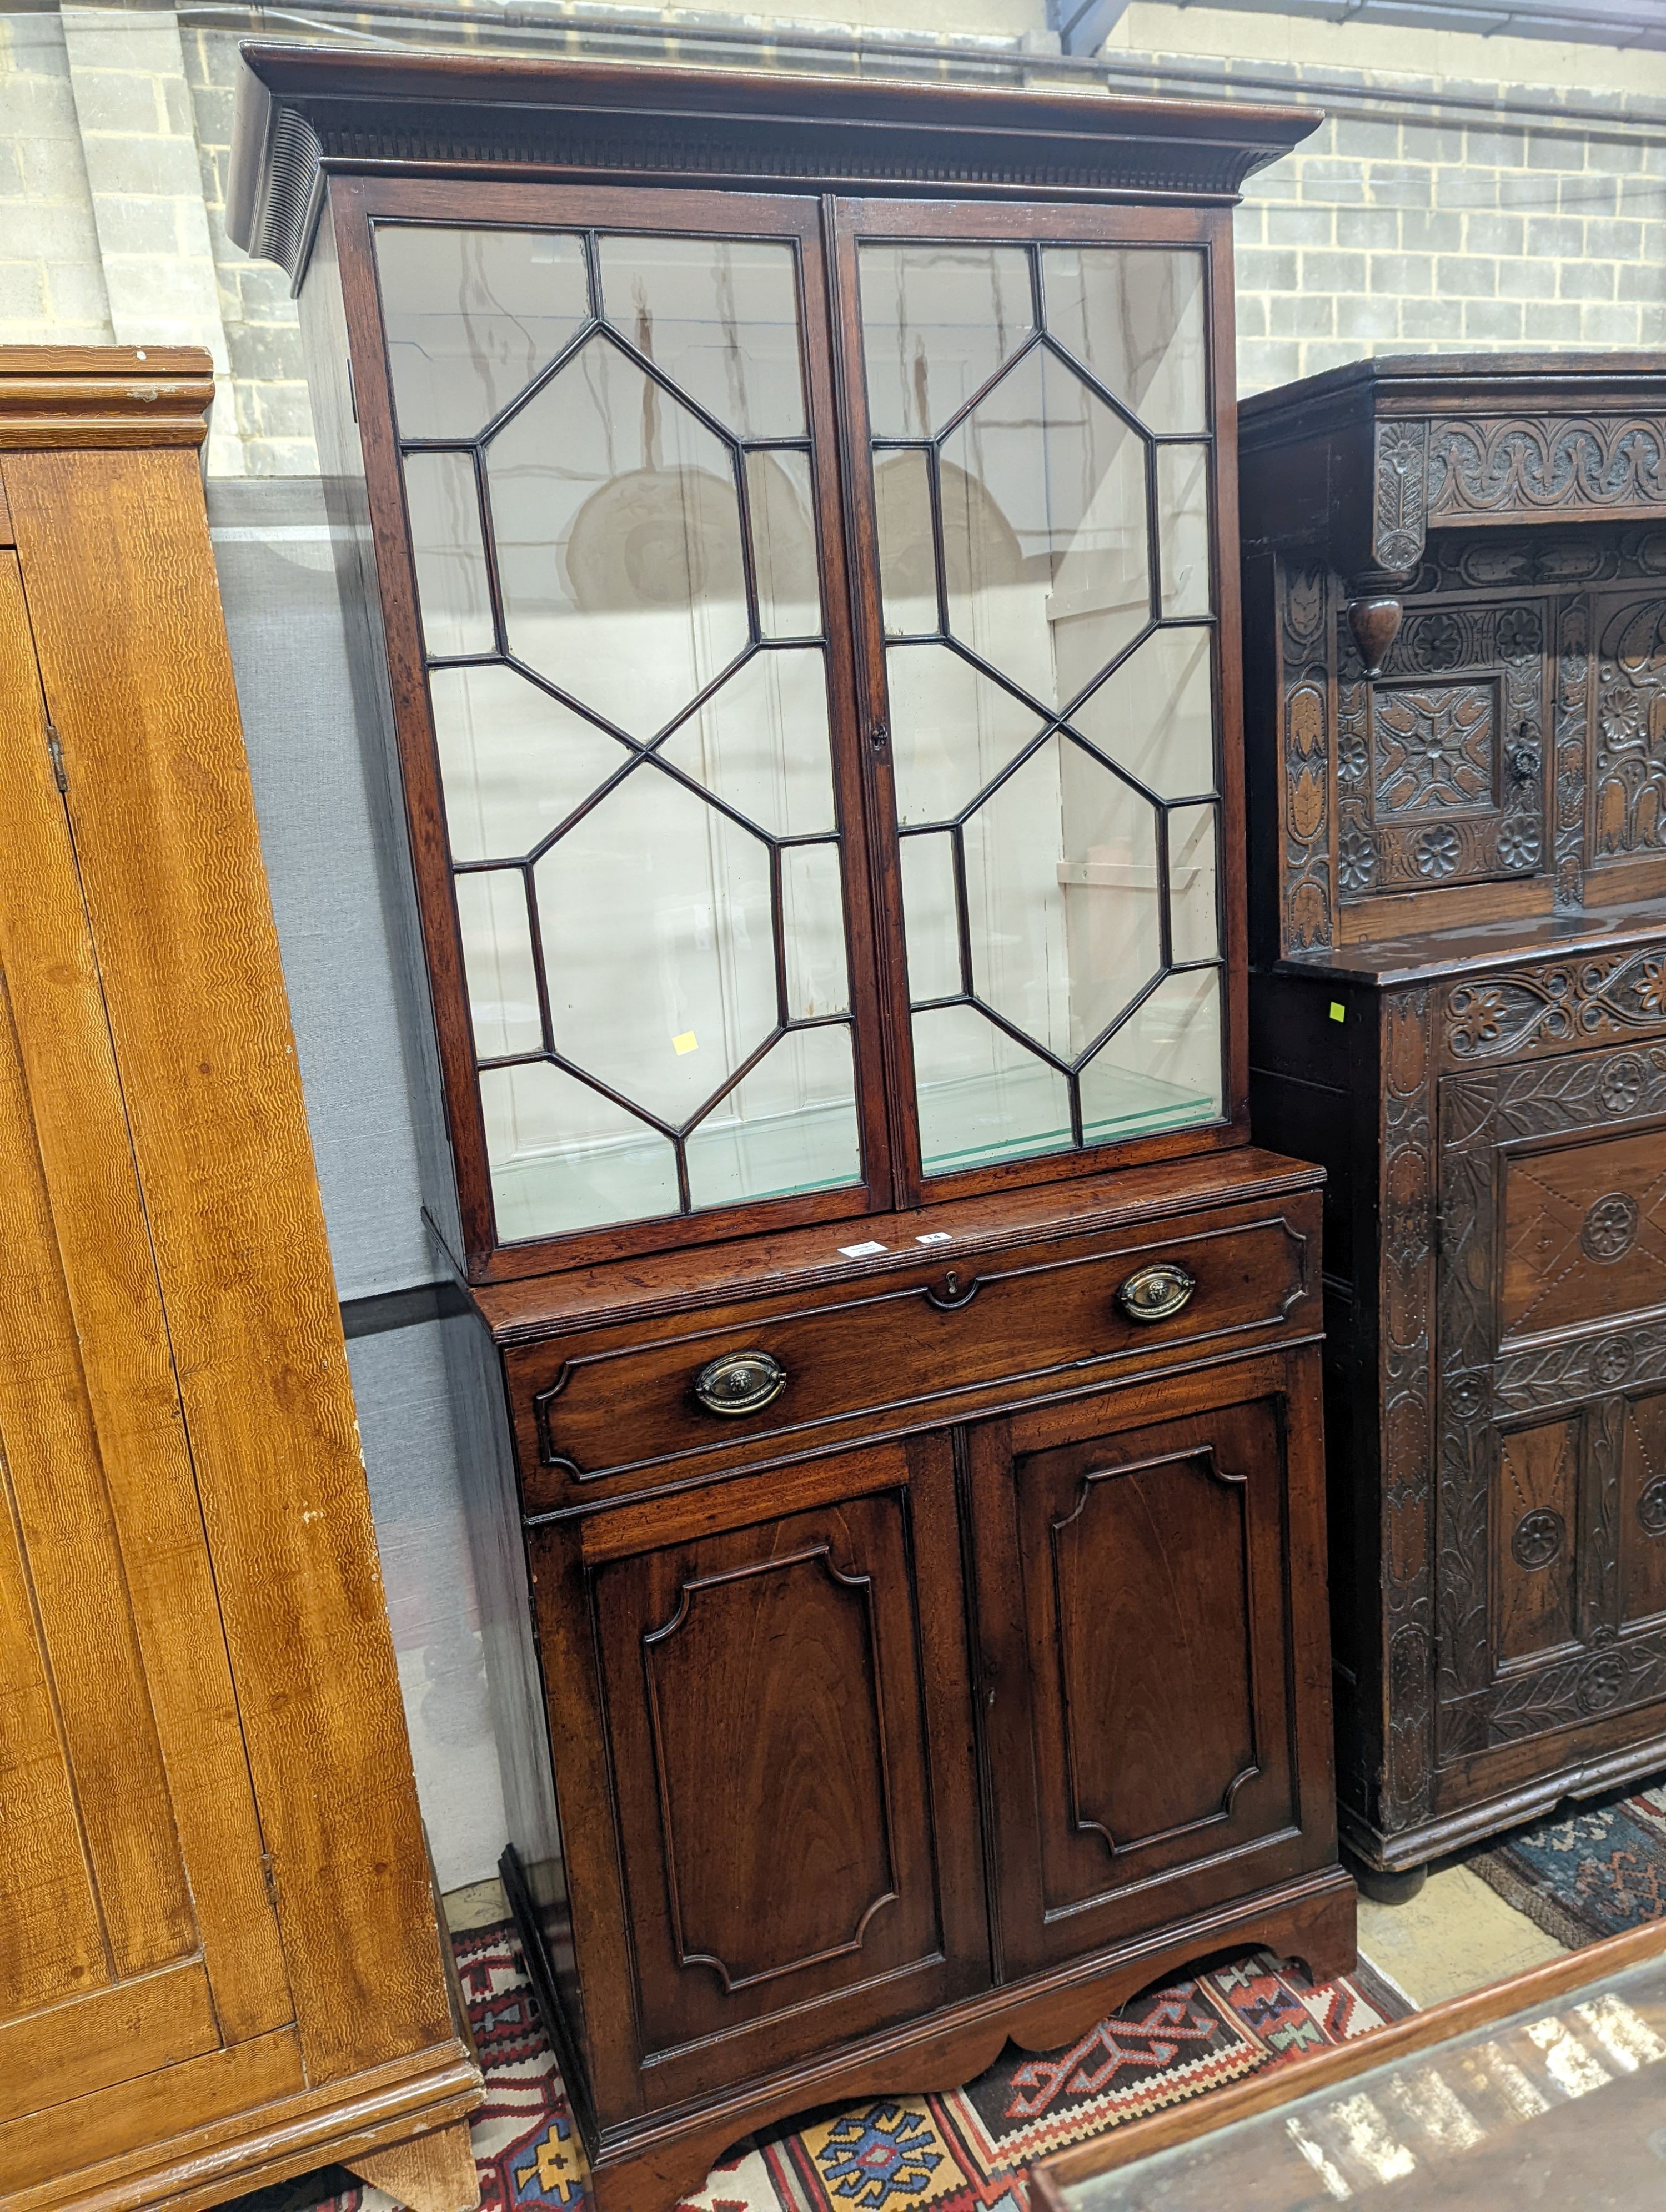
[600,239,803,438]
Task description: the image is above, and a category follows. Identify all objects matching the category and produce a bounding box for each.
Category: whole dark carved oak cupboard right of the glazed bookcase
[1243,356,1666,1873]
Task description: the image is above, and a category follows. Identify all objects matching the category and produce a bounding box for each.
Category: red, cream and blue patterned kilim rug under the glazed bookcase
[230,1924,1407,2212]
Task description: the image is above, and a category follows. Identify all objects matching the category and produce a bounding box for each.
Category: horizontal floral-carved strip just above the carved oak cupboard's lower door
[1443,944,1666,1066]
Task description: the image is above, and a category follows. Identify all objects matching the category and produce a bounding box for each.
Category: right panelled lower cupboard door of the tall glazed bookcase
[971,1382,1297,1975]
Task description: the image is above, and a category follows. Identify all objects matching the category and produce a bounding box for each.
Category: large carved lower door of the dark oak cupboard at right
[1438,1046,1666,1756]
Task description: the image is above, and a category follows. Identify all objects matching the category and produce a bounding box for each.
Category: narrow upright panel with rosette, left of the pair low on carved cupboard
[1493,1418,1580,1666]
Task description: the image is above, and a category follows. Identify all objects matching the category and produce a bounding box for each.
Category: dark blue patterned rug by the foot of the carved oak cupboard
[1464,1785,1666,1951]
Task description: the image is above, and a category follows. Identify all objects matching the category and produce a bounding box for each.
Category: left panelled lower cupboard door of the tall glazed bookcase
[526,1438,989,2095]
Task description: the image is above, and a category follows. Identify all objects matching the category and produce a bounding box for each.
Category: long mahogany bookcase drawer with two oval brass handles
[506,1199,1319,1511]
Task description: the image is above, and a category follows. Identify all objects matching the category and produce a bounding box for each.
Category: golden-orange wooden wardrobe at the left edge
[0,347,480,2212]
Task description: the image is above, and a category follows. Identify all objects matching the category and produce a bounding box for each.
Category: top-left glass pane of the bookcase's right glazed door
[859,245,1033,438]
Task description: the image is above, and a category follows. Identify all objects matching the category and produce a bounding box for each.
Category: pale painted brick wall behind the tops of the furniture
[0,0,1666,476]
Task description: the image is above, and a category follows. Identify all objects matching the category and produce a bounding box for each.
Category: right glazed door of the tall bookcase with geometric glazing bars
[841,202,1239,1197]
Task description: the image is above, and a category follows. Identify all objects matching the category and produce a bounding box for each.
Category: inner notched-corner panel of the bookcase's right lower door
[1051,1451,1257,1856]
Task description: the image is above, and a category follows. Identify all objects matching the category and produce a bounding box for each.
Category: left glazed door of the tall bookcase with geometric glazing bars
[349,186,887,1272]
